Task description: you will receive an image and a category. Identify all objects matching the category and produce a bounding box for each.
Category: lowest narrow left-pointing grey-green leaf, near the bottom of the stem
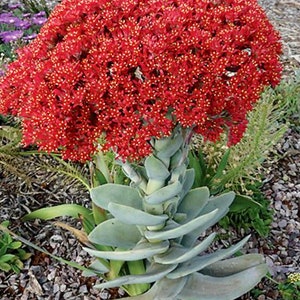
[94,264,177,289]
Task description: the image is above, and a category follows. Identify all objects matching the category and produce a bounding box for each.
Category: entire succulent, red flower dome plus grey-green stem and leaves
[0,0,281,299]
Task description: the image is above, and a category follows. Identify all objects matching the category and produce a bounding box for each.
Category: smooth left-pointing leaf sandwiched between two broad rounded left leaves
[108,203,169,226]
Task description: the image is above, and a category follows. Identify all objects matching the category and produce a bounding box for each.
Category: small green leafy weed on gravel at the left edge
[0,221,31,273]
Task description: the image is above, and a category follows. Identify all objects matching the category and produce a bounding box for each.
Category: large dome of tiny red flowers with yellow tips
[0,0,281,160]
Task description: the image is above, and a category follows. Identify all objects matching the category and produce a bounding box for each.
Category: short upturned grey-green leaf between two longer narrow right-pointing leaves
[154,233,216,264]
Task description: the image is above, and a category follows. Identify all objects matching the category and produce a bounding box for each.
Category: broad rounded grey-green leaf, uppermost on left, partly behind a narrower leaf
[90,183,142,210]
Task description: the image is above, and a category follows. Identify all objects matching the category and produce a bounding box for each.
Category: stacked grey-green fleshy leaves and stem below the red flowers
[84,127,267,300]
